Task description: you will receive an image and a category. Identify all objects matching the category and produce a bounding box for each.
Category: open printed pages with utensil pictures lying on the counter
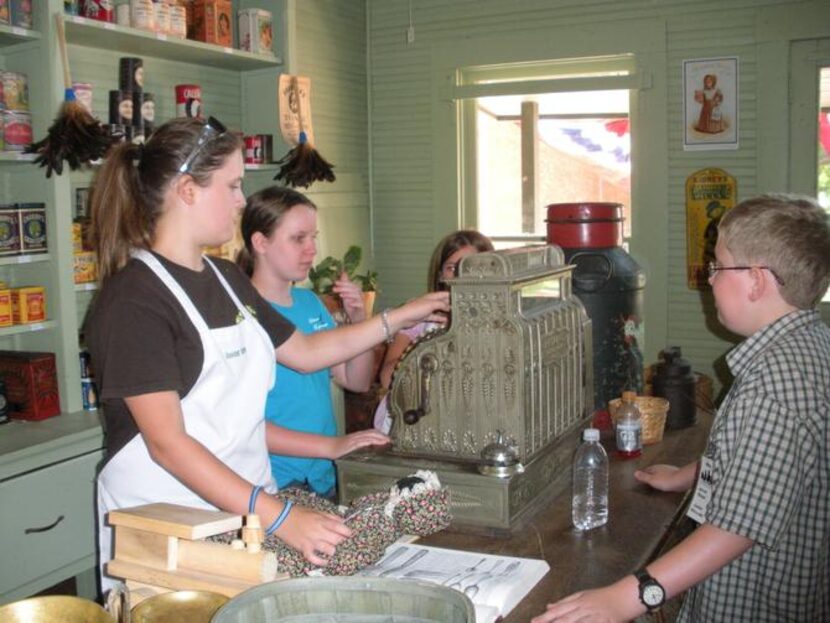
[358,541,550,623]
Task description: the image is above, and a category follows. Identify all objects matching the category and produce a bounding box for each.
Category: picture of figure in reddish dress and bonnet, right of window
[683,56,738,151]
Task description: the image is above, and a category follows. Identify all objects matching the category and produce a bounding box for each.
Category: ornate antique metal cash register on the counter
[337,245,593,531]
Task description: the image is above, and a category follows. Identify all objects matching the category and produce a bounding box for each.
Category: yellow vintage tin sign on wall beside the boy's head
[686,169,738,290]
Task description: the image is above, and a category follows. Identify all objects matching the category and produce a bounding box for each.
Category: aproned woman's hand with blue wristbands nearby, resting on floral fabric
[274,506,352,566]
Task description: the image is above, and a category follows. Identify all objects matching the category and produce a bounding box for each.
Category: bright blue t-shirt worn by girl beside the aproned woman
[272,288,337,494]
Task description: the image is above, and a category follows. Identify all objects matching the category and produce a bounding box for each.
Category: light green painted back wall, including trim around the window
[367,0,830,390]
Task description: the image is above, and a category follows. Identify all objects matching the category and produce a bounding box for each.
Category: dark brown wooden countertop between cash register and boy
[422,413,712,623]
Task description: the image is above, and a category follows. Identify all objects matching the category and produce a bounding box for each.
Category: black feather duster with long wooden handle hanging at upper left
[26,15,113,177]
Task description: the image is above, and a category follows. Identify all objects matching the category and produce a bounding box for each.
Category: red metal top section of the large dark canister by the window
[545,202,623,249]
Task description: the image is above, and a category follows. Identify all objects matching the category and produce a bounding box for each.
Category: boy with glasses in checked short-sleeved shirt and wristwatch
[533,195,830,623]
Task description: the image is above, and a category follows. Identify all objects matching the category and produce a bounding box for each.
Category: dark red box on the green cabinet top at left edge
[0,350,61,420]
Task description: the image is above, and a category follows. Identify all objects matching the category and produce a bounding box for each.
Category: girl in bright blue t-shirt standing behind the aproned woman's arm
[237,186,389,497]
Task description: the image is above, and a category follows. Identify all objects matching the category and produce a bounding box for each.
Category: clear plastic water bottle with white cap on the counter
[571,428,608,530]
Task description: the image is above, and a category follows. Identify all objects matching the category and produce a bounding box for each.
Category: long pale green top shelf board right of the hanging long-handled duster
[64,15,282,70]
